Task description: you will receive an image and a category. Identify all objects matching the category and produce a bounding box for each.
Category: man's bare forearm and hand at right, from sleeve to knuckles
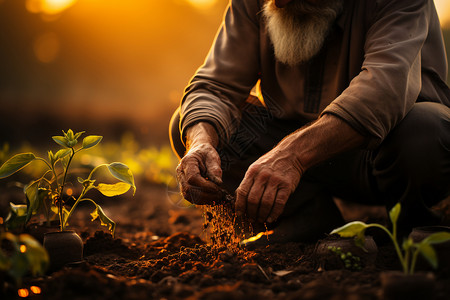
[236,114,365,223]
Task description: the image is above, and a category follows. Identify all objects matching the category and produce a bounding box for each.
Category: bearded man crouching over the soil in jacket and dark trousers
[170,0,450,242]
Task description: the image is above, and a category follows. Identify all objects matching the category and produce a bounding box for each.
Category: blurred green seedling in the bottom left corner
[0,232,49,286]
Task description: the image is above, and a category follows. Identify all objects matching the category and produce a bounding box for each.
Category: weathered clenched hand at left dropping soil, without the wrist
[177,143,223,205]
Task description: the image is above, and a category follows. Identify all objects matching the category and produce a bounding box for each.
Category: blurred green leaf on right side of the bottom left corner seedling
[19,234,49,276]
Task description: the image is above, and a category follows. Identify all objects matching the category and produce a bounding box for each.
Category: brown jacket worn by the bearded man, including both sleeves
[180,0,450,148]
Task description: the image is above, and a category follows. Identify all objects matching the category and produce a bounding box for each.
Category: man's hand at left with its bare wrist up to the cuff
[177,122,223,205]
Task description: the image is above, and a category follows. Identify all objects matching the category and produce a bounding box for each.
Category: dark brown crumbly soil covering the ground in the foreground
[1,184,450,300]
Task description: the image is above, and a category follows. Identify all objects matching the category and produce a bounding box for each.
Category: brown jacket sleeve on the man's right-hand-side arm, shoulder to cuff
[323,0,434,148]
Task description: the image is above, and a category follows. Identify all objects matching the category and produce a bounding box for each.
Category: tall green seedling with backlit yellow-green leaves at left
[0,129,136,235]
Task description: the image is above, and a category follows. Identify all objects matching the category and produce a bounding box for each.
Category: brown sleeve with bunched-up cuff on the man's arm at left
[180,0,260,142]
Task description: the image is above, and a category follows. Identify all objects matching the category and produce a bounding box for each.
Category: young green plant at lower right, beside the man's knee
[331,203,450,274]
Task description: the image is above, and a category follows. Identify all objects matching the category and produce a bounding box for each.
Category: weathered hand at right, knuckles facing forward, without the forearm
[236,143,303,223]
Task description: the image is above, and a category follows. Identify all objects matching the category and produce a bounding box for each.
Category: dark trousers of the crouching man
[169,102,450,238]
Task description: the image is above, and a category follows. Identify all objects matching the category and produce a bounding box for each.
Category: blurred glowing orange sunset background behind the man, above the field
[0,0,450,158]
